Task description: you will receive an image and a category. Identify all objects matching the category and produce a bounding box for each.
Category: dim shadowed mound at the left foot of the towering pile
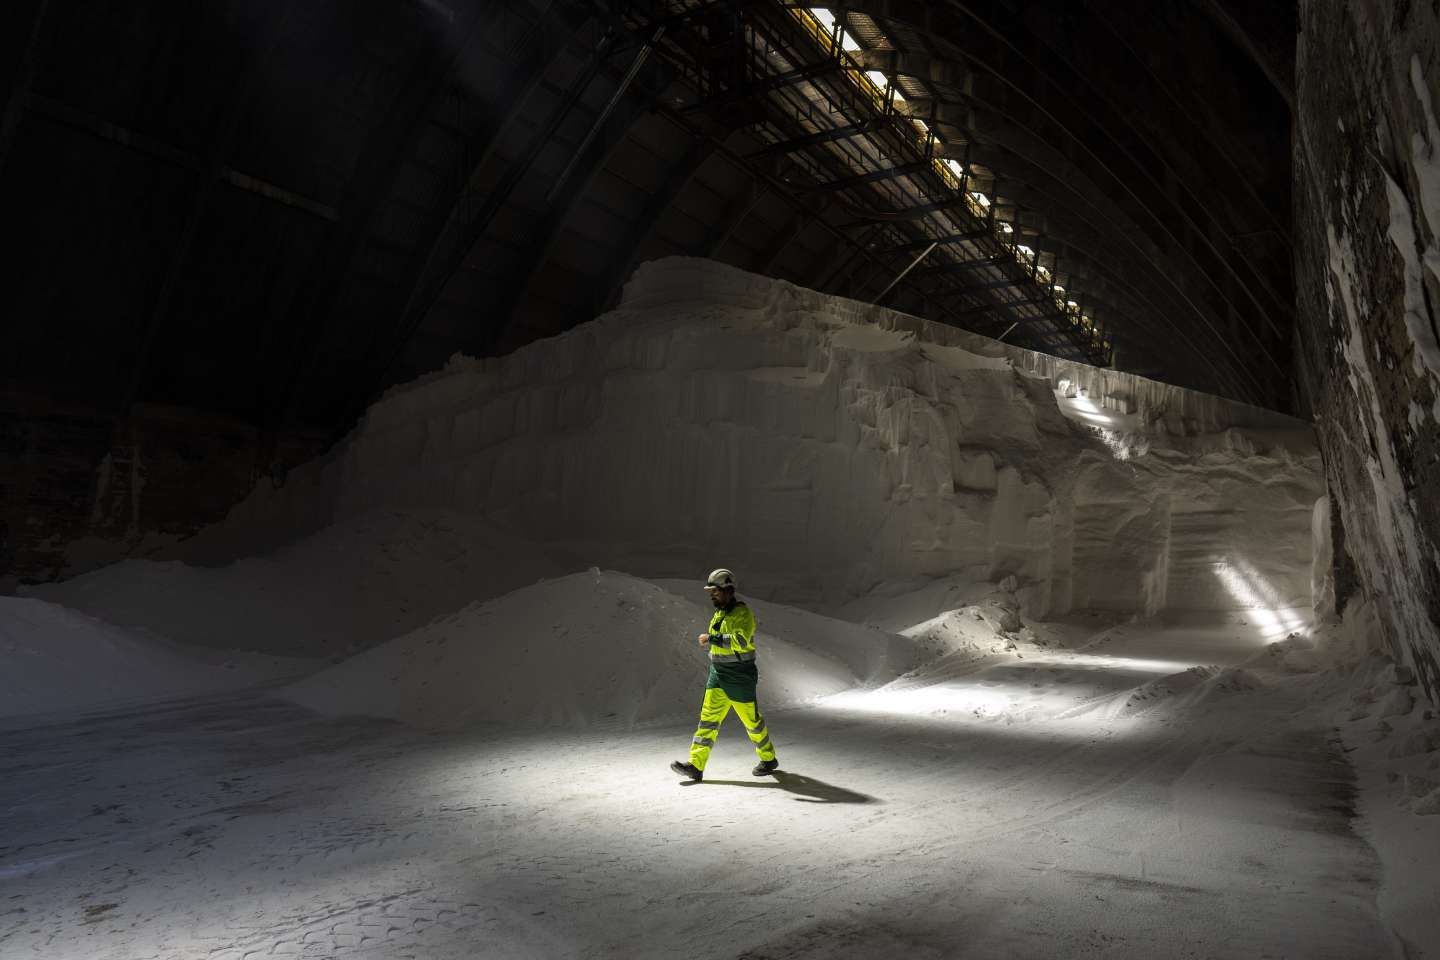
[27,508,567,656]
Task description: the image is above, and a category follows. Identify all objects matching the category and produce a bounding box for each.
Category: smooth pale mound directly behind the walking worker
[284,570,916,728]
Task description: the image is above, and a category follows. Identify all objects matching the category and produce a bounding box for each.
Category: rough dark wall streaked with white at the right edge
[1295,0,1440,702]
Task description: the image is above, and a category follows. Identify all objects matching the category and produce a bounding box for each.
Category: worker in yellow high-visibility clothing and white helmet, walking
[670,567,780,780]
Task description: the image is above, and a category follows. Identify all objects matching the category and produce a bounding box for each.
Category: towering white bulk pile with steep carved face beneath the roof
[35,258,1323,653]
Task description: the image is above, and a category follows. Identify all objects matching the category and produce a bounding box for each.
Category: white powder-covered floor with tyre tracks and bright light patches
[0,618,1390,960]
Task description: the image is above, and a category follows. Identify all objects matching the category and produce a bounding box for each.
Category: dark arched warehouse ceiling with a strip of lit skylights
[0,0,1295,454]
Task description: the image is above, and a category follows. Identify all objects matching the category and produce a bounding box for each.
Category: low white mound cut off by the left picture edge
[0,597,306,717]
